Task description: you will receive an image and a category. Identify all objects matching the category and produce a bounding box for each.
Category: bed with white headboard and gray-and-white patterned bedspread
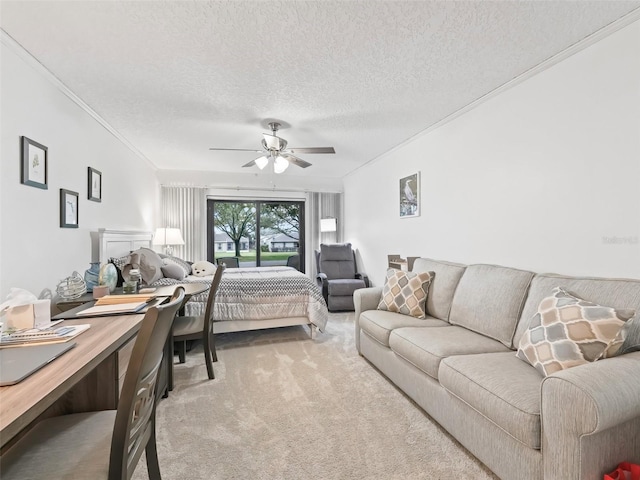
[97,229,329,338]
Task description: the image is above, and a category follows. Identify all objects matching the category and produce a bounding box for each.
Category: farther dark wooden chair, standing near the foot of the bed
[171,265,225,380]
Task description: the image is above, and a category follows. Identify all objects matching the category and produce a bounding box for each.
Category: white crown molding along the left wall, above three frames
[0,29,158,171]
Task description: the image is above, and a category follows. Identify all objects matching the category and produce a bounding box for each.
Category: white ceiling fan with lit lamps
[209,122,336,173]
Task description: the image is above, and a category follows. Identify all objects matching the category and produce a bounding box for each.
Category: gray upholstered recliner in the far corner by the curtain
[316,243,369,312]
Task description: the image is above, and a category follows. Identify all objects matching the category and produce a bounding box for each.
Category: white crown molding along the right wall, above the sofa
[343,7,640,178]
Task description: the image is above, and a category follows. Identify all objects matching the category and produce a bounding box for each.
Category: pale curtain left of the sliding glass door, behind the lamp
[159,186,207,262]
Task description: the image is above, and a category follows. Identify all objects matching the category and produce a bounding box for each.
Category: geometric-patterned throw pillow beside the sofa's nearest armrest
[516,287,635,376]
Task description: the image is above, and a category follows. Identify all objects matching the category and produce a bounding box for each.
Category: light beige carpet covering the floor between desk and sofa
[134,314,497,480]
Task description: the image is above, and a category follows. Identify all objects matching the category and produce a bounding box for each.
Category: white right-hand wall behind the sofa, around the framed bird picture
[345,21,640,285]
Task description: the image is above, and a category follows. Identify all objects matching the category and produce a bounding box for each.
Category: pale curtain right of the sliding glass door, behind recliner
[306,192,344,278]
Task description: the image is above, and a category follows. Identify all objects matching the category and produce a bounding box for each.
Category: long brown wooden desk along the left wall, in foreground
[0,314,144,450]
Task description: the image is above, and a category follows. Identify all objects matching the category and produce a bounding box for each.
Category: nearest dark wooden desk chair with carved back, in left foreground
[0,287,184,480]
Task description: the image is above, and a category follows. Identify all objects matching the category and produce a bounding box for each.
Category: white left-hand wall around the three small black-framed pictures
[0,37,160,299]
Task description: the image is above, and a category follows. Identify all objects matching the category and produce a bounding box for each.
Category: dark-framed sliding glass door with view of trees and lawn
[207,200,304,272]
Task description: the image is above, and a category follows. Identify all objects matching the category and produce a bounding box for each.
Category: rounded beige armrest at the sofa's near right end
[540,352,640,479]
